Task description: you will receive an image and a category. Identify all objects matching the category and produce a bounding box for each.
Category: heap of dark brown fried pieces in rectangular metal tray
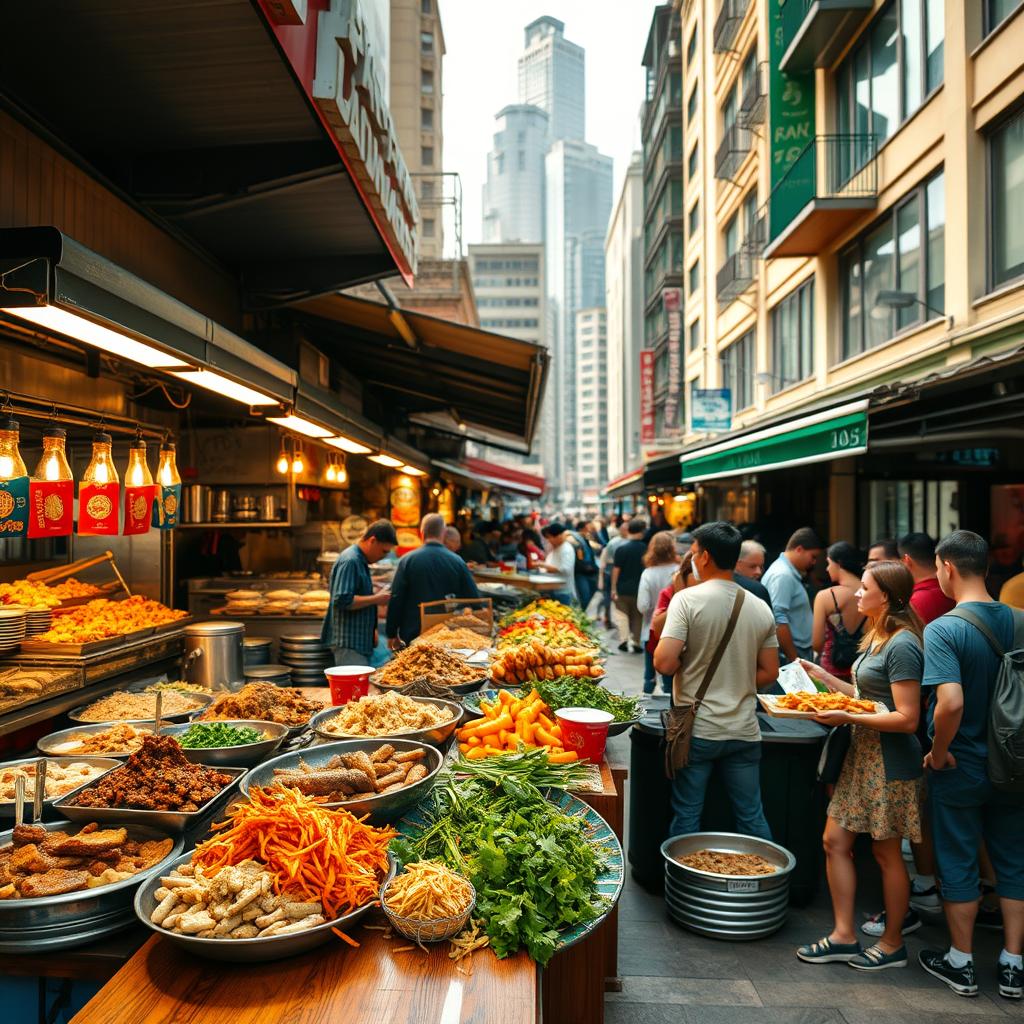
[71,736,232,813]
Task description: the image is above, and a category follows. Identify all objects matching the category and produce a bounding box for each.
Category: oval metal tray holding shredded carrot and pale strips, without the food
[135,853,396,964]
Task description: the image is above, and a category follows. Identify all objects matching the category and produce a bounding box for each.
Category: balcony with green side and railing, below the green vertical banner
[764,135,879,259]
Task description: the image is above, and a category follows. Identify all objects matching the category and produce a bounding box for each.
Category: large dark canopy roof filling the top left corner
[0,0,415,305]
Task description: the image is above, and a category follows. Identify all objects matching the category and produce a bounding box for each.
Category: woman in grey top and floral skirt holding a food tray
[797,561,924,971]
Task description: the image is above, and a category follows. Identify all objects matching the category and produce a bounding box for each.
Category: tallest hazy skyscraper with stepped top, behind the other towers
[519,16,586,139]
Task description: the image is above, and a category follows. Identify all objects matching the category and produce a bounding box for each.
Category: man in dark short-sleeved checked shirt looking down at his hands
[321,519,398,665]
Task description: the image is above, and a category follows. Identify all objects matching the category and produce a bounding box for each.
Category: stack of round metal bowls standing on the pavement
[662,833,797,942]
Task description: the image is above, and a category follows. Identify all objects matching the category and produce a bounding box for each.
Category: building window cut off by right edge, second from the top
[988,112,1024,287]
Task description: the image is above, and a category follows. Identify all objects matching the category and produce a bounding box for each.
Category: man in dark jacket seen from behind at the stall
[385,512,480,650]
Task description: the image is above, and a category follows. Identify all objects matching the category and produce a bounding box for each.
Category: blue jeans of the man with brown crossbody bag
[669,736,771,840]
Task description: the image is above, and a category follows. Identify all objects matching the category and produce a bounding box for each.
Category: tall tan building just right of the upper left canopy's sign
[388,0,452,259]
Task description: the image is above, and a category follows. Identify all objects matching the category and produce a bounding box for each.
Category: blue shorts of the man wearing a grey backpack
[928,766,1024,903]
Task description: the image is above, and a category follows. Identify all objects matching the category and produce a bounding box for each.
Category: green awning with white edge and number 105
[679,401,867,483]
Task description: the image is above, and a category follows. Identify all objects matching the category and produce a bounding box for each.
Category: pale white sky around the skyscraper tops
[439,0,656,244]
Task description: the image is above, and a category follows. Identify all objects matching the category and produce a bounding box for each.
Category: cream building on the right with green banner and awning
[667,0,1024,564]
